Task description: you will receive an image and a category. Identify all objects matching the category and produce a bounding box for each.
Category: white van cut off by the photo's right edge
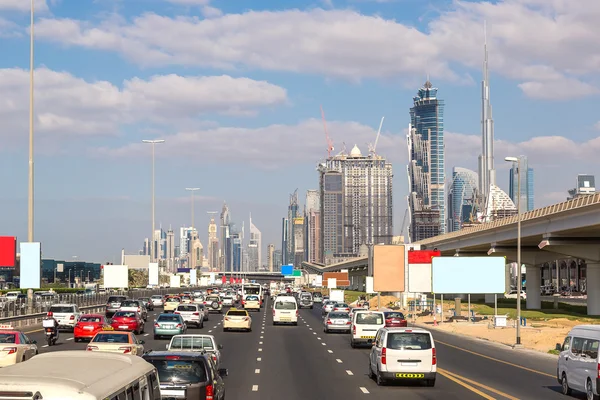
[556,325,600,400]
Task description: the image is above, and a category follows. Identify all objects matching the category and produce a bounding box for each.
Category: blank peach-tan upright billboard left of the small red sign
[373,244,406,292]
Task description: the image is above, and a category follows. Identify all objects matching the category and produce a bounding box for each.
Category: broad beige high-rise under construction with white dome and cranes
[318,146,393,264]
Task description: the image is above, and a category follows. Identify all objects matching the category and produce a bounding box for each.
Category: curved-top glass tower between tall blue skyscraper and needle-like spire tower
[448,167,479,232]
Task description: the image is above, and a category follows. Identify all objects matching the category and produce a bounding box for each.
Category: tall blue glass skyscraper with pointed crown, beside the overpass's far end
[407,80,446,242]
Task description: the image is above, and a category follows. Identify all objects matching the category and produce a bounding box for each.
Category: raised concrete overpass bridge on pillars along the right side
[414,193,600,315]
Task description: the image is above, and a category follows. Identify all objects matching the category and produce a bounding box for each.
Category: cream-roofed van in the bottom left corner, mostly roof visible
[0,350,160,400]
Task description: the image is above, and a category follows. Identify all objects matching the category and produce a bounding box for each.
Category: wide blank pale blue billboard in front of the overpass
[431,256,506,294]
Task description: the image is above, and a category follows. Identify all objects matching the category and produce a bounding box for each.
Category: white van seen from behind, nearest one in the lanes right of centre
[369,327,437,387]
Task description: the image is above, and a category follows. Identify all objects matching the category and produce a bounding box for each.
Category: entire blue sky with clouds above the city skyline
[0,0,600,262]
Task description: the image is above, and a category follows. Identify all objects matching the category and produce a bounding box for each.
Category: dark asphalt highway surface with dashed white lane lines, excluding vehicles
[21,303,568,400]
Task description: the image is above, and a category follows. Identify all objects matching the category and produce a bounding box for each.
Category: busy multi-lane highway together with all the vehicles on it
[0,285,584,400]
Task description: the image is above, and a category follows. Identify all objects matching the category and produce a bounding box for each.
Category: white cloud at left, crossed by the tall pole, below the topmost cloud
[0,68,287,145]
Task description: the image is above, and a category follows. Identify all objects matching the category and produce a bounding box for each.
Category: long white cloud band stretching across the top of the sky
[38,0,600,99]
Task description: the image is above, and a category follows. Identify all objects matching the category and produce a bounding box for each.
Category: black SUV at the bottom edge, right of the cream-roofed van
[143,351,227,400]
